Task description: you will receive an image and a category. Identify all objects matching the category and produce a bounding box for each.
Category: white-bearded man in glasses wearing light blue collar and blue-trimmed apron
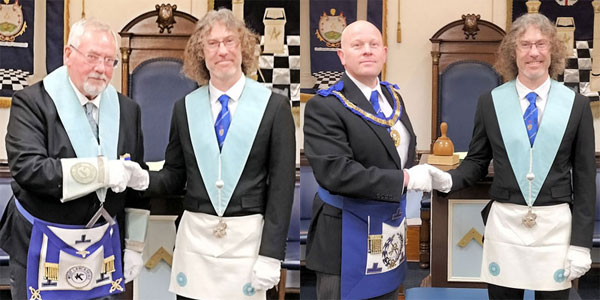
[0,19,148,299]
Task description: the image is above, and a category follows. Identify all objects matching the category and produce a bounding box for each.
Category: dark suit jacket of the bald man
[304,74,416,274]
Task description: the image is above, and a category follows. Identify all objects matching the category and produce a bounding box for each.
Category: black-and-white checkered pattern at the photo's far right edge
[558,41,600,101]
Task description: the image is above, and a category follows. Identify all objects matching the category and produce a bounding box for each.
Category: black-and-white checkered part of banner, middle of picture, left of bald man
[258,35,300,106]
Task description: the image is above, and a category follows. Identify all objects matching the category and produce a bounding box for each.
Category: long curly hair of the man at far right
[494,13,567,81]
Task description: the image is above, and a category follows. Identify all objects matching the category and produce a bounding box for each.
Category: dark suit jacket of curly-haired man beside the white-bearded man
[148,93,296,259]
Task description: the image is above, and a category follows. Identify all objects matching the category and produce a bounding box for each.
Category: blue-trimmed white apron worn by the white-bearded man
[15,199,125,300]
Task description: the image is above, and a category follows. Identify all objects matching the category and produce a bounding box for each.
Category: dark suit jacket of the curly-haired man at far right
[450,89,596,248]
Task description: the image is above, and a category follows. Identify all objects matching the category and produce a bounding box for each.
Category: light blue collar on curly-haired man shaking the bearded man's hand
[185,78,271,216]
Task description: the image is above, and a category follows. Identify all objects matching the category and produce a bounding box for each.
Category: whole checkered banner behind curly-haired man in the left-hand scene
[209,0,300,106]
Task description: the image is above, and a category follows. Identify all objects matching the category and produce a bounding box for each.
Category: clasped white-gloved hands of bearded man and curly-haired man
[107,159,150,193]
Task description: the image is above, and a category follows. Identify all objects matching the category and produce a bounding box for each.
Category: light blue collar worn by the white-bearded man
[44,66,120,159]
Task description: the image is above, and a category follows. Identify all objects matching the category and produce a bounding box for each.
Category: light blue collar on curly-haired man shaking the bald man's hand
[492,80,575,206]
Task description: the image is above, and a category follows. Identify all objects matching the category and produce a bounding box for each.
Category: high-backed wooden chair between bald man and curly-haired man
[419,14,505,268]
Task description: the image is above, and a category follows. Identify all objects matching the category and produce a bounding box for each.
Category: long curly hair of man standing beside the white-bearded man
[183,8,260,85]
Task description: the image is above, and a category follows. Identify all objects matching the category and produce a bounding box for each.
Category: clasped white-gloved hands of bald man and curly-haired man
[405,164,452,193]
